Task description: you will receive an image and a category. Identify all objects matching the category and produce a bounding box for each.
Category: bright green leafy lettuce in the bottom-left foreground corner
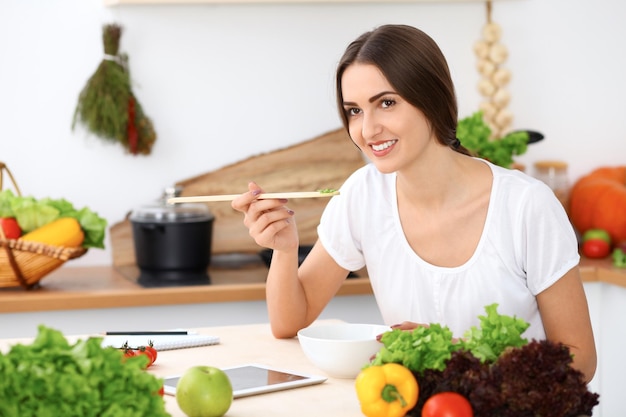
[0,325,169,417]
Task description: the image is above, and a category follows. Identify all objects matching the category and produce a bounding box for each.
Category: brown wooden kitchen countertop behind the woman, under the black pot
[0,254,626,313]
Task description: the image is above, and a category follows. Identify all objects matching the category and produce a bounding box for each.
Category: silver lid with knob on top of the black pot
[130,186,214,223]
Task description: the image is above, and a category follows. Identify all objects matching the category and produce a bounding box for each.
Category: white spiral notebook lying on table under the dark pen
[102,333,220,350]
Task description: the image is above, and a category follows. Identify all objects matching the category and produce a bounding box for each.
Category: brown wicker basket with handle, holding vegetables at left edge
[0,162,87,289]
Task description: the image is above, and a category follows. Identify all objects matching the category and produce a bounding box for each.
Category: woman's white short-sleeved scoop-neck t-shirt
[318,161,580,339]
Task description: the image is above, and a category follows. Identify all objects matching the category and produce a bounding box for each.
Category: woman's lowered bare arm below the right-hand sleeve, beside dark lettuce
[537,267,597,382]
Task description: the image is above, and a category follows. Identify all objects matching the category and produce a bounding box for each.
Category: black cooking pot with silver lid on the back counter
[130,188,214,272]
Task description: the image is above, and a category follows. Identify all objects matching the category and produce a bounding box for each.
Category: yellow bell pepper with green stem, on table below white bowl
[355,363,419,417]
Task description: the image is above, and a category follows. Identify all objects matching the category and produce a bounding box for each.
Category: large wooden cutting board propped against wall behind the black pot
[109,128,365,266]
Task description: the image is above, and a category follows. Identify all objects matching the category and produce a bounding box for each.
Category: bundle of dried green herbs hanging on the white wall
[72,24,156,155]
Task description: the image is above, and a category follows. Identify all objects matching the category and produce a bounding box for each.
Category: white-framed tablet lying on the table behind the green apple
[163,363,327,398]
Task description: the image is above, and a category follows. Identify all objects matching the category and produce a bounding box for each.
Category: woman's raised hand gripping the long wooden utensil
[231,182,299,250]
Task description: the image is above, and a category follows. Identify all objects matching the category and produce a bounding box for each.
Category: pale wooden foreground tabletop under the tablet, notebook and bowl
[0,320,362,417]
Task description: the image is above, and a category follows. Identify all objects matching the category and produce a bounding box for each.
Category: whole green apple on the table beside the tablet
[176,365,233,417]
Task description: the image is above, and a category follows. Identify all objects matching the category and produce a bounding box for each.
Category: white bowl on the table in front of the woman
[298,323,391,378]
